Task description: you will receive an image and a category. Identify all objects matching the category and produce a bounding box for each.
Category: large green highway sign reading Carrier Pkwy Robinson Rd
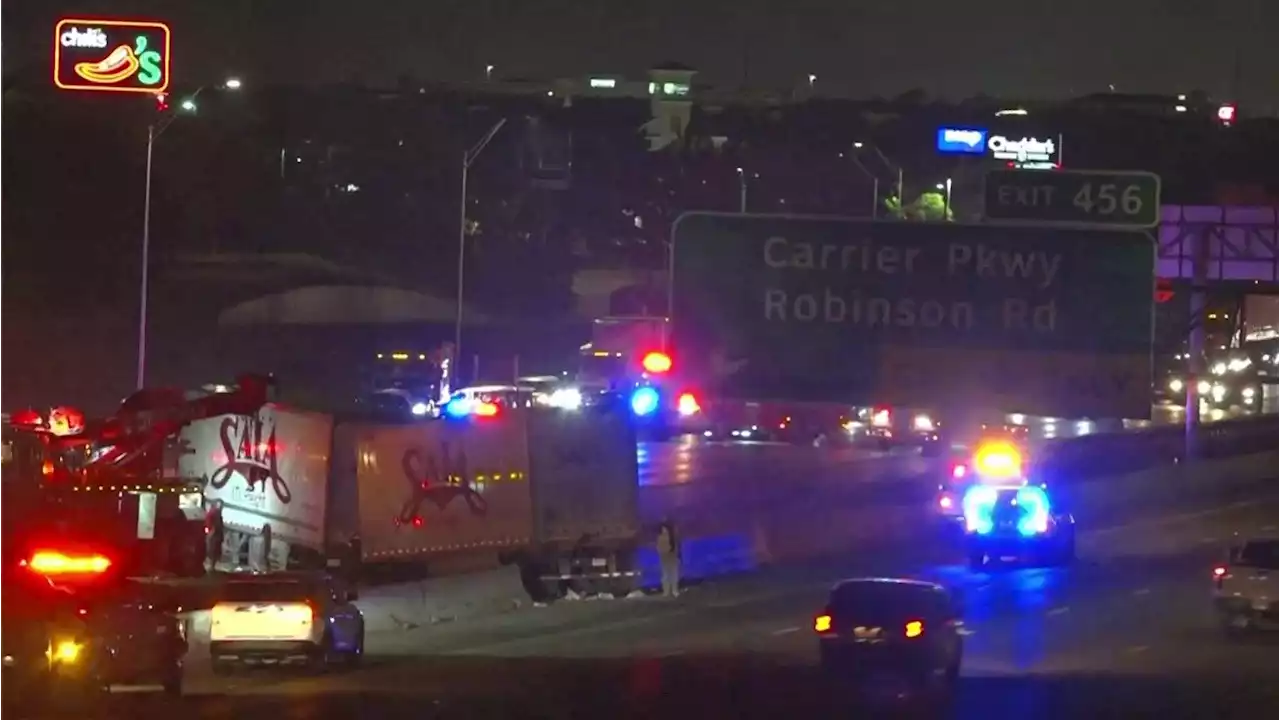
[671,213,1156,418]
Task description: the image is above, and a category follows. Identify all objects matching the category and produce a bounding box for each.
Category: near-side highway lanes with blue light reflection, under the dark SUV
[72,489,1280,720]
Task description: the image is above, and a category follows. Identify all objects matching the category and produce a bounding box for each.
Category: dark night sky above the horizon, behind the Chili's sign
[3,0,1280,114]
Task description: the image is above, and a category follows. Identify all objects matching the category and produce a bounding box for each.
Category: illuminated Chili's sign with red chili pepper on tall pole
[54,18,169,94]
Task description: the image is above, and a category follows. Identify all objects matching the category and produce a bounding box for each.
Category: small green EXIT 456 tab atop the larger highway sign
[983,169,1160,228]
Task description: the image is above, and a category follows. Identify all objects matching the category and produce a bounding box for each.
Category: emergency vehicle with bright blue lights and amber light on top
[959,439,1075,570]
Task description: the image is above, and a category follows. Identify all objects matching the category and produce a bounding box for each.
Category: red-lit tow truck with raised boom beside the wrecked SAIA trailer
[0,375,271,577]
